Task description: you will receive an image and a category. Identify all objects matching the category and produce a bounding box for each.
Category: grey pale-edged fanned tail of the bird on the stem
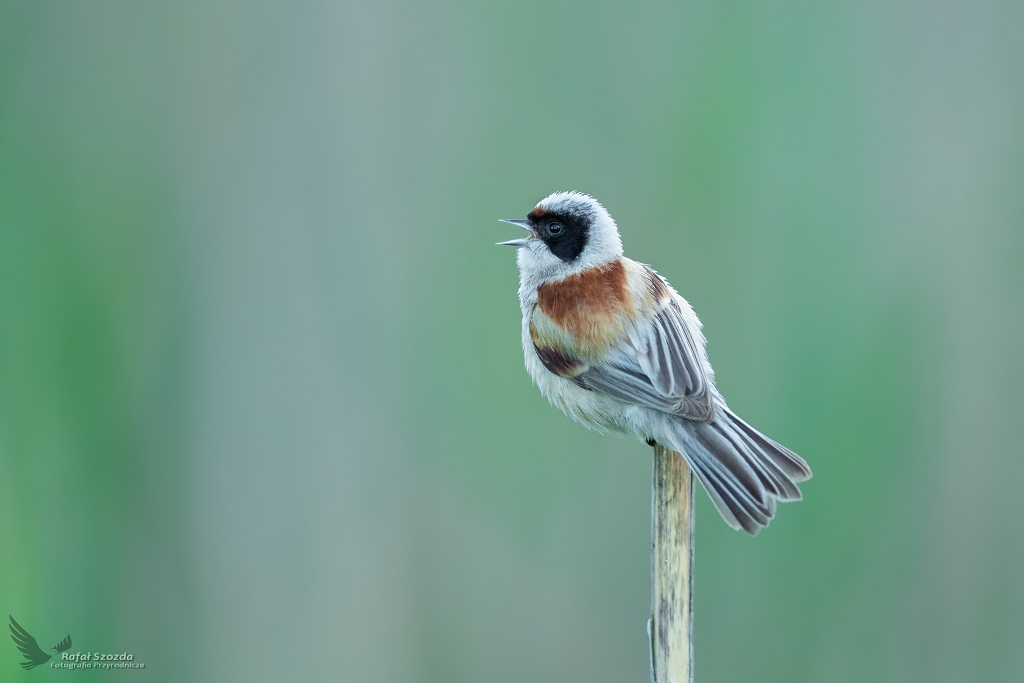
[667,403,811,535]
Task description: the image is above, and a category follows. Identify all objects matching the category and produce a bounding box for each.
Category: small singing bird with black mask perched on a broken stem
[498,190,811,536]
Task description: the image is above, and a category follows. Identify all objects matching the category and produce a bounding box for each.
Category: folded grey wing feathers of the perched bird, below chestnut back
[574,299,715,422]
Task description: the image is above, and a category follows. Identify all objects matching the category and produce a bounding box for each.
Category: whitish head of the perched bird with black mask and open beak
[499,191,623,282]
